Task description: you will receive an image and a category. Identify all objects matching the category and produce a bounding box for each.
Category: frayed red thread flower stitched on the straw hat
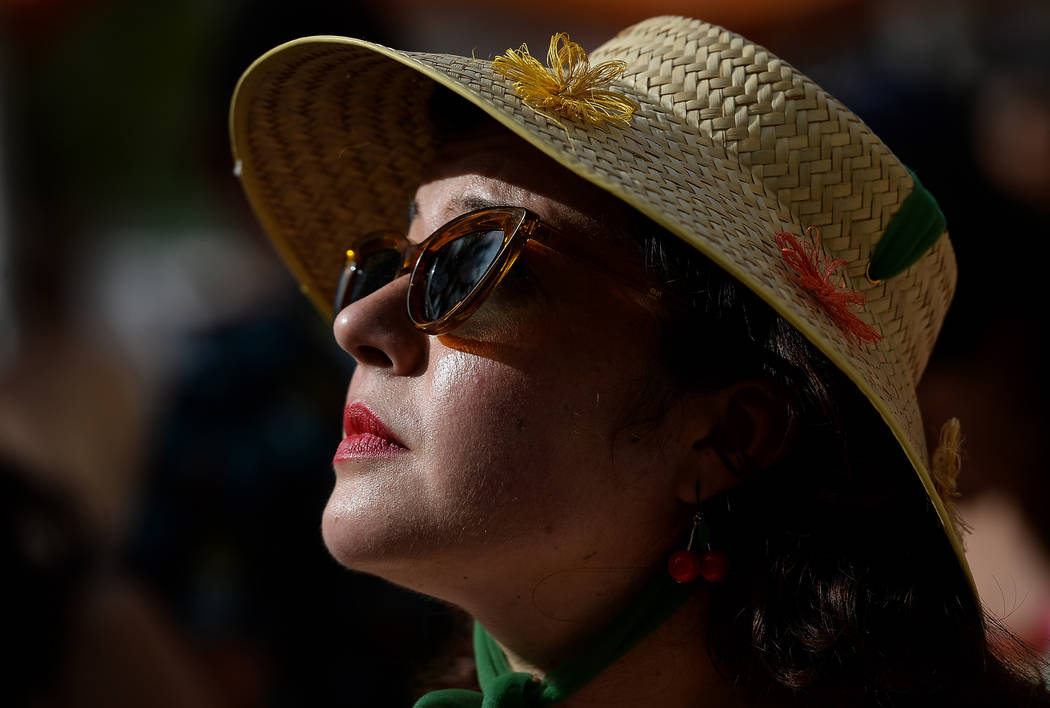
[777,226,882,342]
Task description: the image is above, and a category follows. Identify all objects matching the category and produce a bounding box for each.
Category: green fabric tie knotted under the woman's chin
[414,574,695,708]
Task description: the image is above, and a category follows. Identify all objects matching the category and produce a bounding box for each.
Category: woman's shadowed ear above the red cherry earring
[676,380,797,504]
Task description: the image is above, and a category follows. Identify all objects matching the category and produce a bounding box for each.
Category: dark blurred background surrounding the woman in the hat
[0,0,1050,707]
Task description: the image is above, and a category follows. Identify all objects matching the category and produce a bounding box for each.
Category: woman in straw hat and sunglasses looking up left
[231,13,1045,706]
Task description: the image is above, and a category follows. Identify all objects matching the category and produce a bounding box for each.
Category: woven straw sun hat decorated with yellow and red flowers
[230,17,972,584]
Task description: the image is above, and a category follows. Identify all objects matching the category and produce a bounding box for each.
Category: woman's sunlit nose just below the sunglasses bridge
[332,275,428,376]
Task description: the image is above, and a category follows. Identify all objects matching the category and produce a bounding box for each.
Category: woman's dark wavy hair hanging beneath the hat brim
[634,216,1050,706]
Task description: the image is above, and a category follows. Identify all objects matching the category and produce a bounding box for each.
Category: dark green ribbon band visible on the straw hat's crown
[867,167,947,283]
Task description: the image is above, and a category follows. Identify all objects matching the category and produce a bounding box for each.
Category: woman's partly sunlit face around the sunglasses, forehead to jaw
[323,128,709,602]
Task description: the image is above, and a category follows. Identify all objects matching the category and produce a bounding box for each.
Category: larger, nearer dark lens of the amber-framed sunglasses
[423,230,503,321]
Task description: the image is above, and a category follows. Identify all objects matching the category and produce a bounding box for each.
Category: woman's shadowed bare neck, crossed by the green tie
[373,529,742,708]
